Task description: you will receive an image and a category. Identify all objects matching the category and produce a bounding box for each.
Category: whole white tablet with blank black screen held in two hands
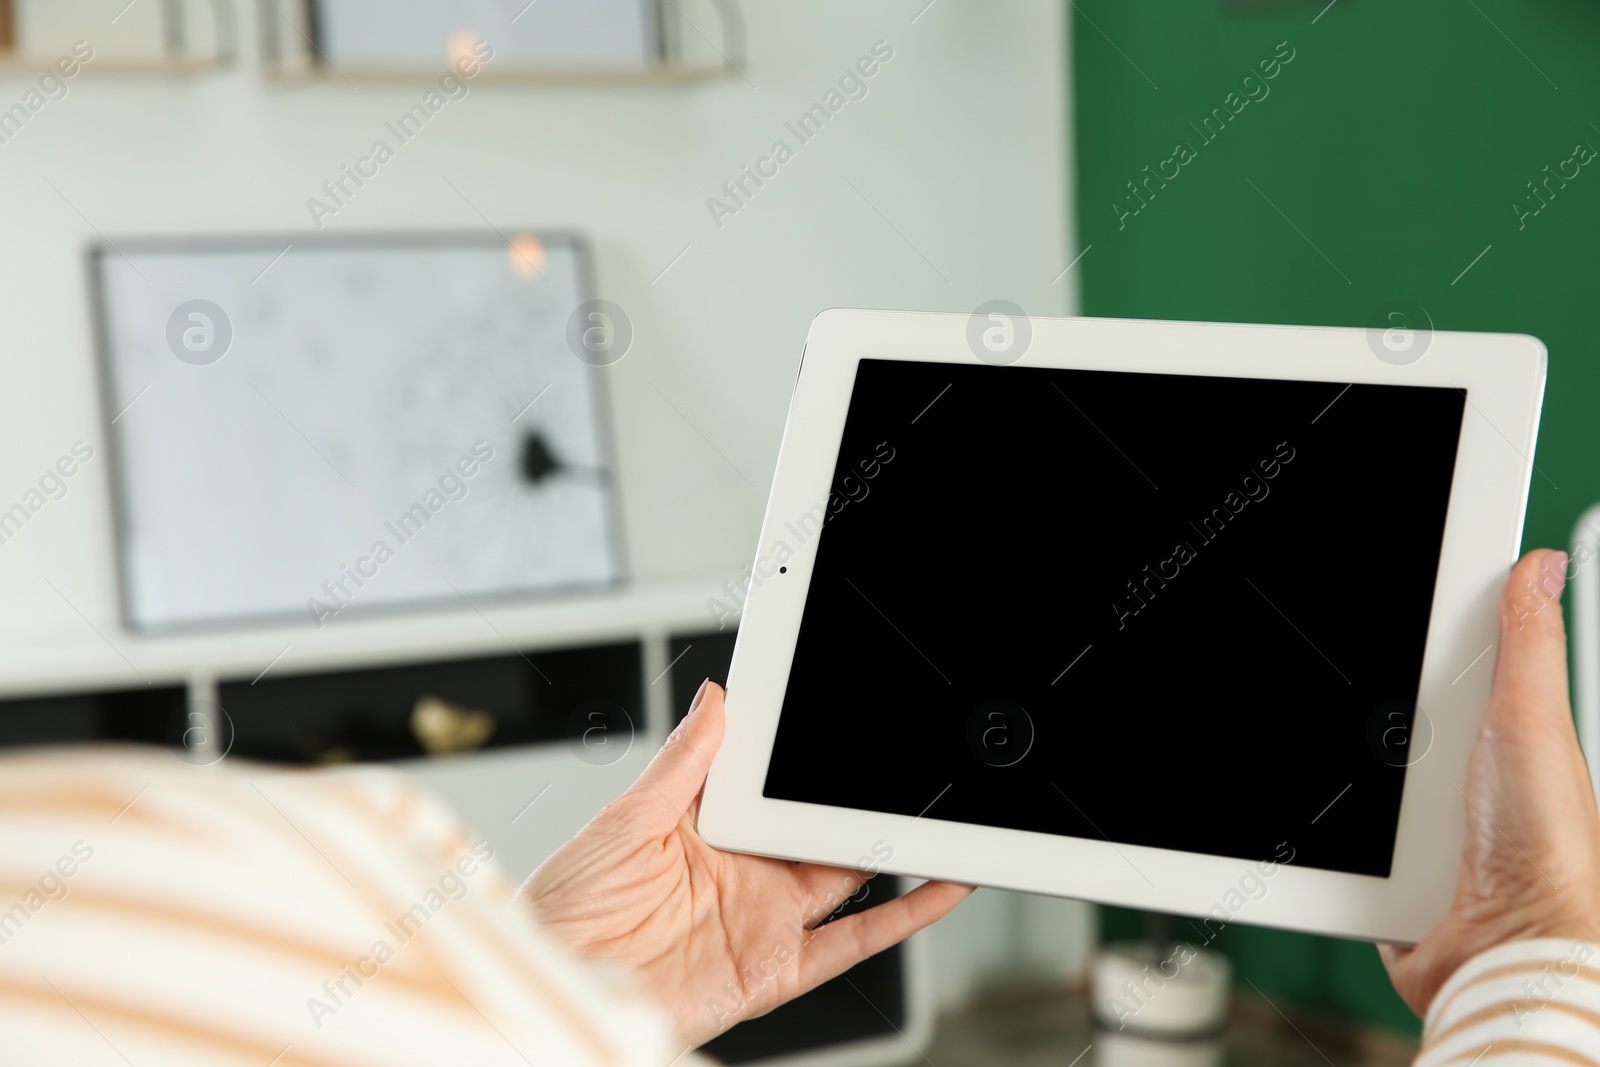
[699,310,1546,942]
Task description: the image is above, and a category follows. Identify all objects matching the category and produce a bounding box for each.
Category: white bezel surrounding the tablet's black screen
[699,309,1546,942]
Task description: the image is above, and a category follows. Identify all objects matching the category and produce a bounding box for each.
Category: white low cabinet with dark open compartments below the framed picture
[0,577,733,873]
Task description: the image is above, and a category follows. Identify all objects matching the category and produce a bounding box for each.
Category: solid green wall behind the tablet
[1070,0,1600,1032]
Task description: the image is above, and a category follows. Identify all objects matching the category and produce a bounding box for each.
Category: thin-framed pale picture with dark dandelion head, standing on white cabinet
[91,234,621,630]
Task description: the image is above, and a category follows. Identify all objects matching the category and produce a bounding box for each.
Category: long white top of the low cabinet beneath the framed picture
[0,577,726,696]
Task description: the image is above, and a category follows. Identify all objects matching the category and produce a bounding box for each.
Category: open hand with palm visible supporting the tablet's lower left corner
[518,681,971,1045]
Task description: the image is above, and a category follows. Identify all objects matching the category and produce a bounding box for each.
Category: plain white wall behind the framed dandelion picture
[0,0,1085,989]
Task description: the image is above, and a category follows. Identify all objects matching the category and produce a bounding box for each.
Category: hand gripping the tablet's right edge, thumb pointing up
[1379,549,1600,1016]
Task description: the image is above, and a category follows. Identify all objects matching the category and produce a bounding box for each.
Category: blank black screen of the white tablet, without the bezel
[765,360,1466,877]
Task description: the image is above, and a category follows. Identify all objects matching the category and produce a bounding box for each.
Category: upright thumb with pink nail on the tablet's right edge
[1490,549,1571,723]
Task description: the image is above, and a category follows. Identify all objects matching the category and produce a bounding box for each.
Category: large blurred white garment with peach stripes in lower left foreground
[0,749,704,1067]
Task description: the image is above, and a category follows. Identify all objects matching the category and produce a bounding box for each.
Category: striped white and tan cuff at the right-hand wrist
[1416,939,1600,1067]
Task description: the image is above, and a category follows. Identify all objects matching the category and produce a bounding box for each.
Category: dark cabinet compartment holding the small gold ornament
[218,641,646,763]
